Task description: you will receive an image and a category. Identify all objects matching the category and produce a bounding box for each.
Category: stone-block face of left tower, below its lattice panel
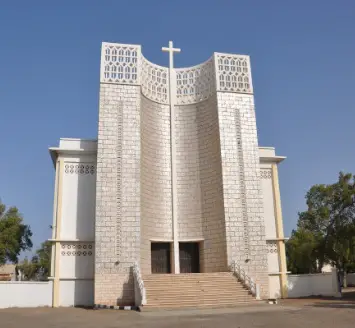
[95,83,140,305]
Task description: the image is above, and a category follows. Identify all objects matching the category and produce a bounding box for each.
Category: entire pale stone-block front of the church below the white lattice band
[95,83,268,304]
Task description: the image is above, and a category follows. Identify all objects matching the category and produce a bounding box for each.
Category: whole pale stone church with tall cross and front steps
[49,42,287,307]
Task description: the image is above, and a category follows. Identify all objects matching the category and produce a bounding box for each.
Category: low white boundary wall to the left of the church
[0,281,53,309]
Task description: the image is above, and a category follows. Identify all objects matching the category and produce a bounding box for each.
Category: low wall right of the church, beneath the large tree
[287,270,340,298]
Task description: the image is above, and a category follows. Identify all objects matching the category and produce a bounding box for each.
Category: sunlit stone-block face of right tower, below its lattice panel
[217,92,268,298]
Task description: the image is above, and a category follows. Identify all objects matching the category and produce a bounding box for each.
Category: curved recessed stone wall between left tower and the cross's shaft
[141,95,173,274]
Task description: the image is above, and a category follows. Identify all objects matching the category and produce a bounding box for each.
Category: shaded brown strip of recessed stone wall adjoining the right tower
[195,95,228,272]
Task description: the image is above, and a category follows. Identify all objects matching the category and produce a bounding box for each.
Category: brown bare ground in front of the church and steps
[0,298,355,328]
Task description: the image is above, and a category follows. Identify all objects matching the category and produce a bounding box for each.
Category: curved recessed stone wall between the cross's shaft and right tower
[175,96,227,272]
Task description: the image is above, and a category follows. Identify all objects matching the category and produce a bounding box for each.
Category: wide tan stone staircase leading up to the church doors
[143,272,256,309]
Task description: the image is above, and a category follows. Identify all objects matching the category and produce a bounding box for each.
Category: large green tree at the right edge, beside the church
[288,173,355,285]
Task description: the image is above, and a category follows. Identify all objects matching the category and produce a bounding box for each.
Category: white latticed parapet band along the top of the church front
[100,42,253,105]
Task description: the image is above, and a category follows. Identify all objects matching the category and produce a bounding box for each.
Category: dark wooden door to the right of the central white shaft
[179,243,200,273]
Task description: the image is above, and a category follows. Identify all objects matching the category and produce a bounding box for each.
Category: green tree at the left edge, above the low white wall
[0,201,32,265]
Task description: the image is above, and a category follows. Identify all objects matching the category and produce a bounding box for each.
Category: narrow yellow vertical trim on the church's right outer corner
[271,164,287,298]
